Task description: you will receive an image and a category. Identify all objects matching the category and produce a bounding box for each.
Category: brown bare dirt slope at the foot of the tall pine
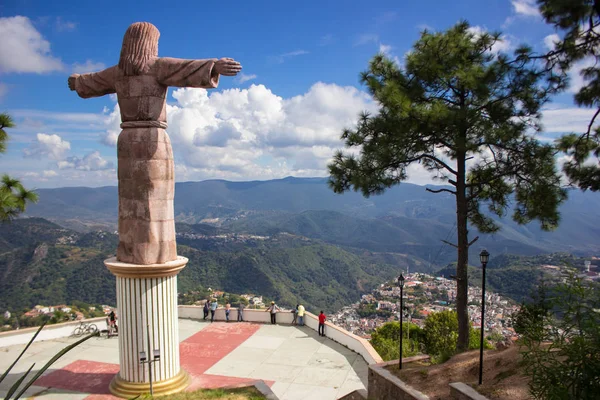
[388,345,532,400]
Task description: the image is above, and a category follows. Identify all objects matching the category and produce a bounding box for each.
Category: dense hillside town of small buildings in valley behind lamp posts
[330,273,518,338]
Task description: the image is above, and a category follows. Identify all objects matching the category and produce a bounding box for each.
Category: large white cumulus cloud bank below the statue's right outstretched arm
[103,83,376,181]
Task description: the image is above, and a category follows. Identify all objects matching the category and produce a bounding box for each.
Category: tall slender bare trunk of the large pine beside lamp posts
[456,149,469,351]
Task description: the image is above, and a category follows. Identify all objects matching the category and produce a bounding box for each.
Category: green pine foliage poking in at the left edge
[0,113,38,222]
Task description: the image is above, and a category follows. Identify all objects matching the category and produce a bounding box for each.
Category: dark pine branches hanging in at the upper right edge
[538,0,600,191]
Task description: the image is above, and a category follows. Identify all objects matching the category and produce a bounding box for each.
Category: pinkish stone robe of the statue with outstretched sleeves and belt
[75,57,219,265]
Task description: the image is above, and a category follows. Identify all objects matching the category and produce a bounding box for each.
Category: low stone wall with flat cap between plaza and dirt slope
[368,356,429,400]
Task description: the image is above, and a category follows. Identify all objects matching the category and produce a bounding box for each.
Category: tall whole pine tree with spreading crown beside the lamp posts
[329,22,566,350]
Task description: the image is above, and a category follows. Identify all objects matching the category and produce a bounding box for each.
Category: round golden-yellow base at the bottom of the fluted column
[110,369,191,399]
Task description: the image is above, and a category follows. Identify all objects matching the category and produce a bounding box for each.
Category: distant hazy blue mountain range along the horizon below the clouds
[21,177,600,264]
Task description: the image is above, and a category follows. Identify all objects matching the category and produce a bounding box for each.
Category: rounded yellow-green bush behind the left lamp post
[371,321,423,361]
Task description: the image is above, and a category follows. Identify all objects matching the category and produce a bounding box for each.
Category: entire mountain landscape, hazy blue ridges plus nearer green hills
[0,178,600,312]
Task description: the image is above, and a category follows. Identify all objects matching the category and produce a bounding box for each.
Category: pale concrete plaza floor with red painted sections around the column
[0,319,368,400]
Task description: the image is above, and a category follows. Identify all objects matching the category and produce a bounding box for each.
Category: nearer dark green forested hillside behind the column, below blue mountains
[0,219,429,311]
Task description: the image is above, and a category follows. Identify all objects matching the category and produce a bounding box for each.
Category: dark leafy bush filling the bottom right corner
[516,274,600,400]
